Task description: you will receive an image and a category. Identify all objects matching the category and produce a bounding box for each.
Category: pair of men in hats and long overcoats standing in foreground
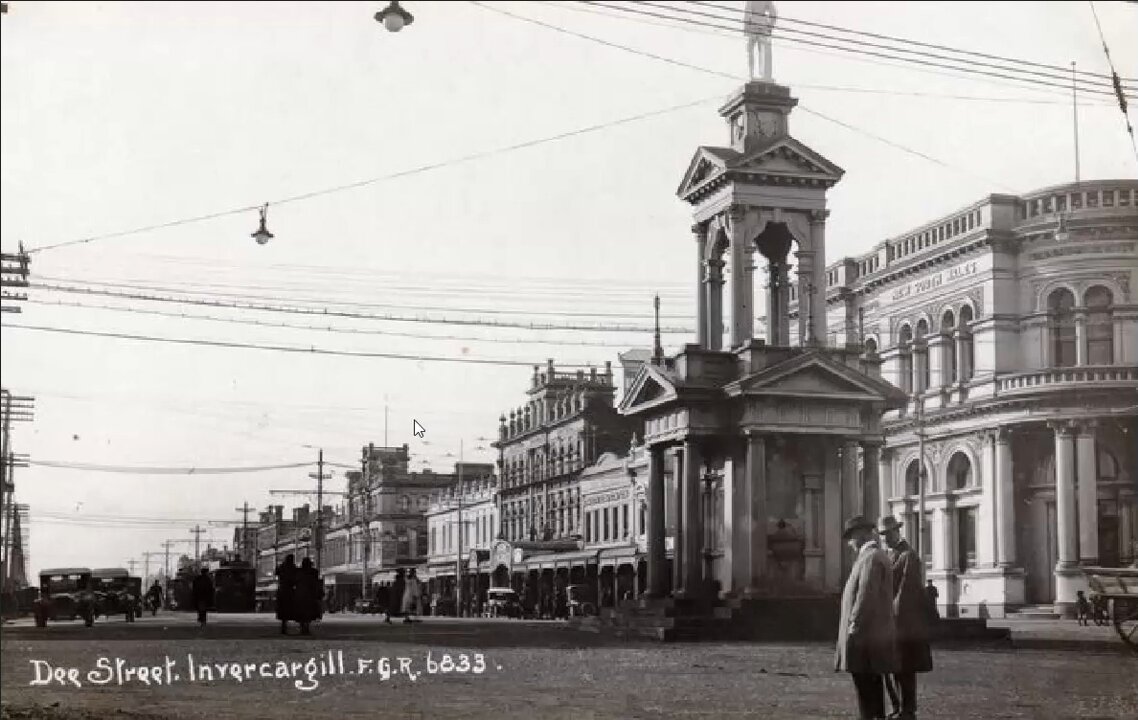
[834,516,932,720]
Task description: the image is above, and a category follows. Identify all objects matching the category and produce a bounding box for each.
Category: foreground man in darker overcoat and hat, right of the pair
[877,515,932,720]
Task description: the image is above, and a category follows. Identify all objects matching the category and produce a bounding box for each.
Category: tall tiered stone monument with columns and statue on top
[620,21,906,637]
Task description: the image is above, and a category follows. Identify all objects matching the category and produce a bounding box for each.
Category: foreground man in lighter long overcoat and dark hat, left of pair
[834,515,896,720]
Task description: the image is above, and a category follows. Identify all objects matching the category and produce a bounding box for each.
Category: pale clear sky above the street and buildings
[0,0,1138,573]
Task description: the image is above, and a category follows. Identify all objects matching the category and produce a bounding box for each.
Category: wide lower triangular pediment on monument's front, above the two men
[726,353,906,407]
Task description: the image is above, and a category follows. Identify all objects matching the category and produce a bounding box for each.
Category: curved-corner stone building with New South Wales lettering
[791,181,1138,616]
